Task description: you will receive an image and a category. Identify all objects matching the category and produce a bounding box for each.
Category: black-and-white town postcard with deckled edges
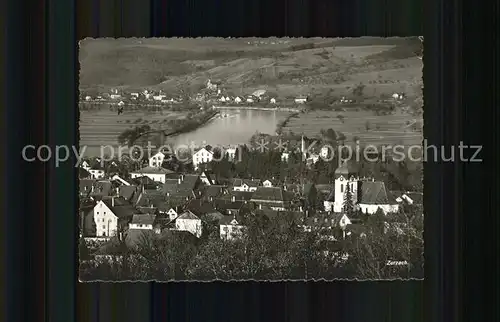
[80,36,424,282]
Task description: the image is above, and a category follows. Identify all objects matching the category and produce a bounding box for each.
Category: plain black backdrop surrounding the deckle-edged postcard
[0,0,490,322]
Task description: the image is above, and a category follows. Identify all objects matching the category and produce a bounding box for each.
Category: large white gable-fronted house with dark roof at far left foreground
[94,197,135,237]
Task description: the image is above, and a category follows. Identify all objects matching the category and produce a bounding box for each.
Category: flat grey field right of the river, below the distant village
[283,110,423,145]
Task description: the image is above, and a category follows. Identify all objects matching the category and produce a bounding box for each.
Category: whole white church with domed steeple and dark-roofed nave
[324,162,399,214]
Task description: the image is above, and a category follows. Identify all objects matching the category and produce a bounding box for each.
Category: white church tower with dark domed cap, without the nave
[333,162,360,212]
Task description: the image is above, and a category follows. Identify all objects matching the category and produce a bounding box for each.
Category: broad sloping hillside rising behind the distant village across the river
[79,37,422,96]
